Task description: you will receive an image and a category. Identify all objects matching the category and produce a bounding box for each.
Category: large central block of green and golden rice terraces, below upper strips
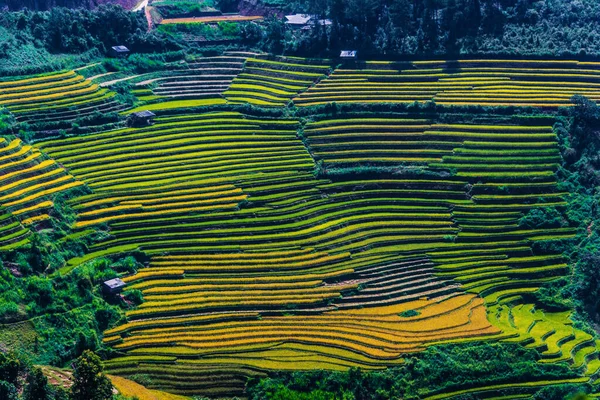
[37,103,596,395]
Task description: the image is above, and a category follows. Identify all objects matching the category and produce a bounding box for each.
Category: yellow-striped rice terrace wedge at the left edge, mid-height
[0,139,83,251]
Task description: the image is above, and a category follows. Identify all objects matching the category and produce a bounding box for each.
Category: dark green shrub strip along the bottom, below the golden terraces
[249,343,587,400]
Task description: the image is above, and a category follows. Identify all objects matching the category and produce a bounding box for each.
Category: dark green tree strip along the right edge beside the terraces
[538,96,600,324]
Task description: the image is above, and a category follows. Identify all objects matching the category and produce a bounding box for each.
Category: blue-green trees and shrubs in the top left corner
[0,5,180,74]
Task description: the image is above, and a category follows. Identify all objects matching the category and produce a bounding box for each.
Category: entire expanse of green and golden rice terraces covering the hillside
[0,53,600,399]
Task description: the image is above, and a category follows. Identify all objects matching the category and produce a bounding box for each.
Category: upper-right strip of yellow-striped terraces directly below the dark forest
[294,60,600,108]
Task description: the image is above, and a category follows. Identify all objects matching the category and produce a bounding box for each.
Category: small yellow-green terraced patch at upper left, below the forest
[0,71,124,130]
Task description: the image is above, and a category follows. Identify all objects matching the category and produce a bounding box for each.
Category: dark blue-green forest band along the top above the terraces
[0,0,600,74]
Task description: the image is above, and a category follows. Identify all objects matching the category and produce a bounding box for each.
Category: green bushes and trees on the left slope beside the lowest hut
[0,252,134,365]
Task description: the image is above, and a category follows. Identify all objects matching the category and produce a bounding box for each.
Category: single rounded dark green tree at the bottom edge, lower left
[71,350,112,400]
